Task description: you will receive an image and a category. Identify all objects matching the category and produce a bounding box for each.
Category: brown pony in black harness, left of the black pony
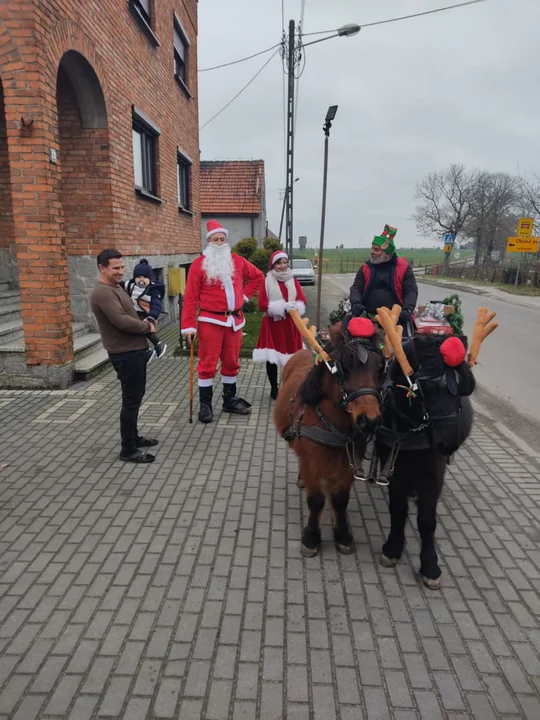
[274,323,385,557]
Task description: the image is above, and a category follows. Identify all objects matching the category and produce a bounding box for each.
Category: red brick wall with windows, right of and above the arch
[36,0,200,254]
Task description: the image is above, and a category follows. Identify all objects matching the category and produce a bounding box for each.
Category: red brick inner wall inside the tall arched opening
[57,67,113,255]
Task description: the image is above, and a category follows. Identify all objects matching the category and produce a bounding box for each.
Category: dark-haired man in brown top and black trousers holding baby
[90,250,158,463]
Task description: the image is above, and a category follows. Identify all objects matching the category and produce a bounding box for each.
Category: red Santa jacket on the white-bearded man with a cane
[182,253,264,334]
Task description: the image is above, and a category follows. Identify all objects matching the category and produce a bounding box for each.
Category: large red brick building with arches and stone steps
[0,0,200,387]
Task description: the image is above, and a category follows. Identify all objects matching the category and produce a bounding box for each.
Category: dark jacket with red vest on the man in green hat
[350,254,418,313]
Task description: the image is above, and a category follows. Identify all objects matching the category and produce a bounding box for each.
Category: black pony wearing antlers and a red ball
[369,308,498,590]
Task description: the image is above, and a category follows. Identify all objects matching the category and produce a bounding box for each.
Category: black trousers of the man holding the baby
[109,350,148,456]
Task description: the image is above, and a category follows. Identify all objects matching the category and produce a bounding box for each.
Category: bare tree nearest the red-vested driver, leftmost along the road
[412,165,477,238]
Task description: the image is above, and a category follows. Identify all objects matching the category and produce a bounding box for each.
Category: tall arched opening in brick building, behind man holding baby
[56,50,114,324]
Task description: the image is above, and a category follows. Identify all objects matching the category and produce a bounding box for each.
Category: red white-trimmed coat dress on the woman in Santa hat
[253,278,306,367]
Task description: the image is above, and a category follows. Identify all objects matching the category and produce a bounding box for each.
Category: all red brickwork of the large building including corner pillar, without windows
[0,0,200,364]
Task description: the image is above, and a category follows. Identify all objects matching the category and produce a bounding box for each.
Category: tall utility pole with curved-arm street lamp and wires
[284,20,362,260]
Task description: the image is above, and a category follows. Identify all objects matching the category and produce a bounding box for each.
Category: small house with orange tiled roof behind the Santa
[201,160,267,248]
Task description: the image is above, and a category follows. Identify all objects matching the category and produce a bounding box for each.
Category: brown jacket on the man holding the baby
[90,281,152,354]
